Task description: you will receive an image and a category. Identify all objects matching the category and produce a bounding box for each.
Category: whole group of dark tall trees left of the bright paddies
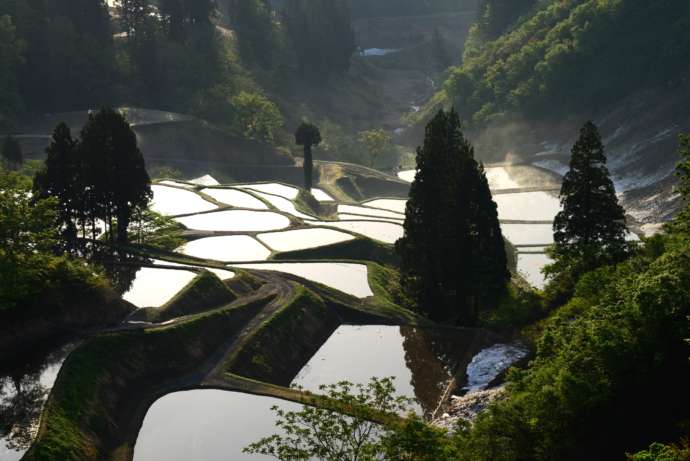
[34,109,151,250]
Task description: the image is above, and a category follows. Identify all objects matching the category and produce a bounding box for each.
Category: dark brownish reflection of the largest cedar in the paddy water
[400,327,477,414]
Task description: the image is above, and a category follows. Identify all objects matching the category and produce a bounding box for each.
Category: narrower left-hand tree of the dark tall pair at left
[33,123,78,250]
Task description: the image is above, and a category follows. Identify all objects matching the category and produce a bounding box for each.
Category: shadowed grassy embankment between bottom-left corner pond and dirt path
[24,294,266,461]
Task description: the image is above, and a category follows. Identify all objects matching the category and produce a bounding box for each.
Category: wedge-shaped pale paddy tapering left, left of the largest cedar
[235,263,374,298]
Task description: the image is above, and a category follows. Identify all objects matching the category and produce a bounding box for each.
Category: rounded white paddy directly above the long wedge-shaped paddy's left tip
[177,235,271,262]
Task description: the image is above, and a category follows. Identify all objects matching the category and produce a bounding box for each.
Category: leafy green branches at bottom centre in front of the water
[244,378,455,461]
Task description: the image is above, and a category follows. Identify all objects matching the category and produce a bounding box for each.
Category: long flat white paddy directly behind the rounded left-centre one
[176,210,290,232]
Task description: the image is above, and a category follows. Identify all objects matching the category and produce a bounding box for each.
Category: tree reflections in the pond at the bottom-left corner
[0,346,71,451]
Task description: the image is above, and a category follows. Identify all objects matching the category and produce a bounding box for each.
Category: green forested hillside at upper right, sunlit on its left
[422,0,690,123]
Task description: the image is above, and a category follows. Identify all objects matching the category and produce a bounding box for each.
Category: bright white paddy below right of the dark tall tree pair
[122,267,197,308]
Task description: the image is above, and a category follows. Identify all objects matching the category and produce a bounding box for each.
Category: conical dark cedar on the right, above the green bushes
[553,121,628,276]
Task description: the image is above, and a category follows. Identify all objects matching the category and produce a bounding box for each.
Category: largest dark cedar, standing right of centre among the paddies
[396,110,510,325]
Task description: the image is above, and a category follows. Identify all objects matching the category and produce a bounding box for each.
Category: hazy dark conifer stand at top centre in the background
[284,0,356,82]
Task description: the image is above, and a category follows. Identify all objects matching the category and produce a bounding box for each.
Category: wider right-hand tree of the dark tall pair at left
[80,108,152,242]
